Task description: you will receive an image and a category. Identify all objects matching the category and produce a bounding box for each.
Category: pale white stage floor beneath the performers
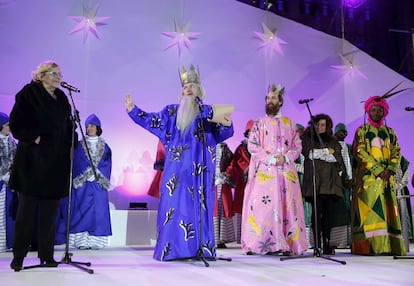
[0,244,414,286]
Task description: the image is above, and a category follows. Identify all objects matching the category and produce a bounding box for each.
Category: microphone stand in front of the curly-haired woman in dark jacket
[280,101,346,265]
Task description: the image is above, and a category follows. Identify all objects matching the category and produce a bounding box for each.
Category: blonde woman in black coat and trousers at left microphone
[9,61,77,271]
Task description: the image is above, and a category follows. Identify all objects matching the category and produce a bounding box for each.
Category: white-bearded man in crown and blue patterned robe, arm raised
[126,66,234,261]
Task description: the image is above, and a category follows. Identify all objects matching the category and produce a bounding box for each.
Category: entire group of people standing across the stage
[0,62,414,271]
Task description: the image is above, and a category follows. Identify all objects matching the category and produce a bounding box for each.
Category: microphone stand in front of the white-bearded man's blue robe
[192,101,232,267]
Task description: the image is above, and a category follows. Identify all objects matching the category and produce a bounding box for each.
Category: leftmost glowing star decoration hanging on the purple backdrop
[69,5,111,43]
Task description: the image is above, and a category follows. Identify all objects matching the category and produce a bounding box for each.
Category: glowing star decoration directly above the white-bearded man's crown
[161,21,201,57]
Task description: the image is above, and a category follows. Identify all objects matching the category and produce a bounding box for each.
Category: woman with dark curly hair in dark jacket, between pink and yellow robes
[302,114,344,254]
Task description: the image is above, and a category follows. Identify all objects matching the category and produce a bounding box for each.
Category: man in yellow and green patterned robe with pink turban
[351,96,406,255]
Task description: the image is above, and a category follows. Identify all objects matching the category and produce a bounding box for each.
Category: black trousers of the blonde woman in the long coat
[13,193,60,260]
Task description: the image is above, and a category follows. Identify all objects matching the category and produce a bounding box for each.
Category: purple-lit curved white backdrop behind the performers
[0,0,414,208]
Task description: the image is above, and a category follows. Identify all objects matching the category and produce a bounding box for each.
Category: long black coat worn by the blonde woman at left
[9,82,77,198]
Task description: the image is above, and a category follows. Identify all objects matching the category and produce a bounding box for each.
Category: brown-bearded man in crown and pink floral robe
[242,85,307,255]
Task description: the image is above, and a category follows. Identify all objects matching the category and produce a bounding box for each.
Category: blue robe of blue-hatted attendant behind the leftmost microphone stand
[55,138,112,244]
